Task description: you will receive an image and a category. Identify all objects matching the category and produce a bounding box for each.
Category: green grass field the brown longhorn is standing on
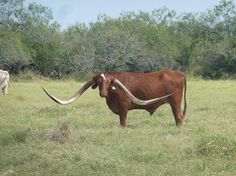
[0,80,236,176]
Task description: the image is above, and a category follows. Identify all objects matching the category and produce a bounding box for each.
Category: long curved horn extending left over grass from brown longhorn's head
[42,80,94,105]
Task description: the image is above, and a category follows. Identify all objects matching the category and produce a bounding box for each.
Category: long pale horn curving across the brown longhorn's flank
[114,79,172,105]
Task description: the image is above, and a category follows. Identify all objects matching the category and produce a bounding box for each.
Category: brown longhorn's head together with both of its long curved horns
[42,73,171,105]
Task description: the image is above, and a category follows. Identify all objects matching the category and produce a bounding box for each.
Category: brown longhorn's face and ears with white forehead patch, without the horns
[92,73,114,97]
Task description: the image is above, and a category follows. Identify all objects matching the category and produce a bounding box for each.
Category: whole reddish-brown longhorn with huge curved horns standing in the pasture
[42,71,186,126]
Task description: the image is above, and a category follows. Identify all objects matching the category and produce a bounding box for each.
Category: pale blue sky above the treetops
[25,0,236,29]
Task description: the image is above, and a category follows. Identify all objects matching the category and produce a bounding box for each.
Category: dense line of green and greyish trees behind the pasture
[0,0,236,79]
